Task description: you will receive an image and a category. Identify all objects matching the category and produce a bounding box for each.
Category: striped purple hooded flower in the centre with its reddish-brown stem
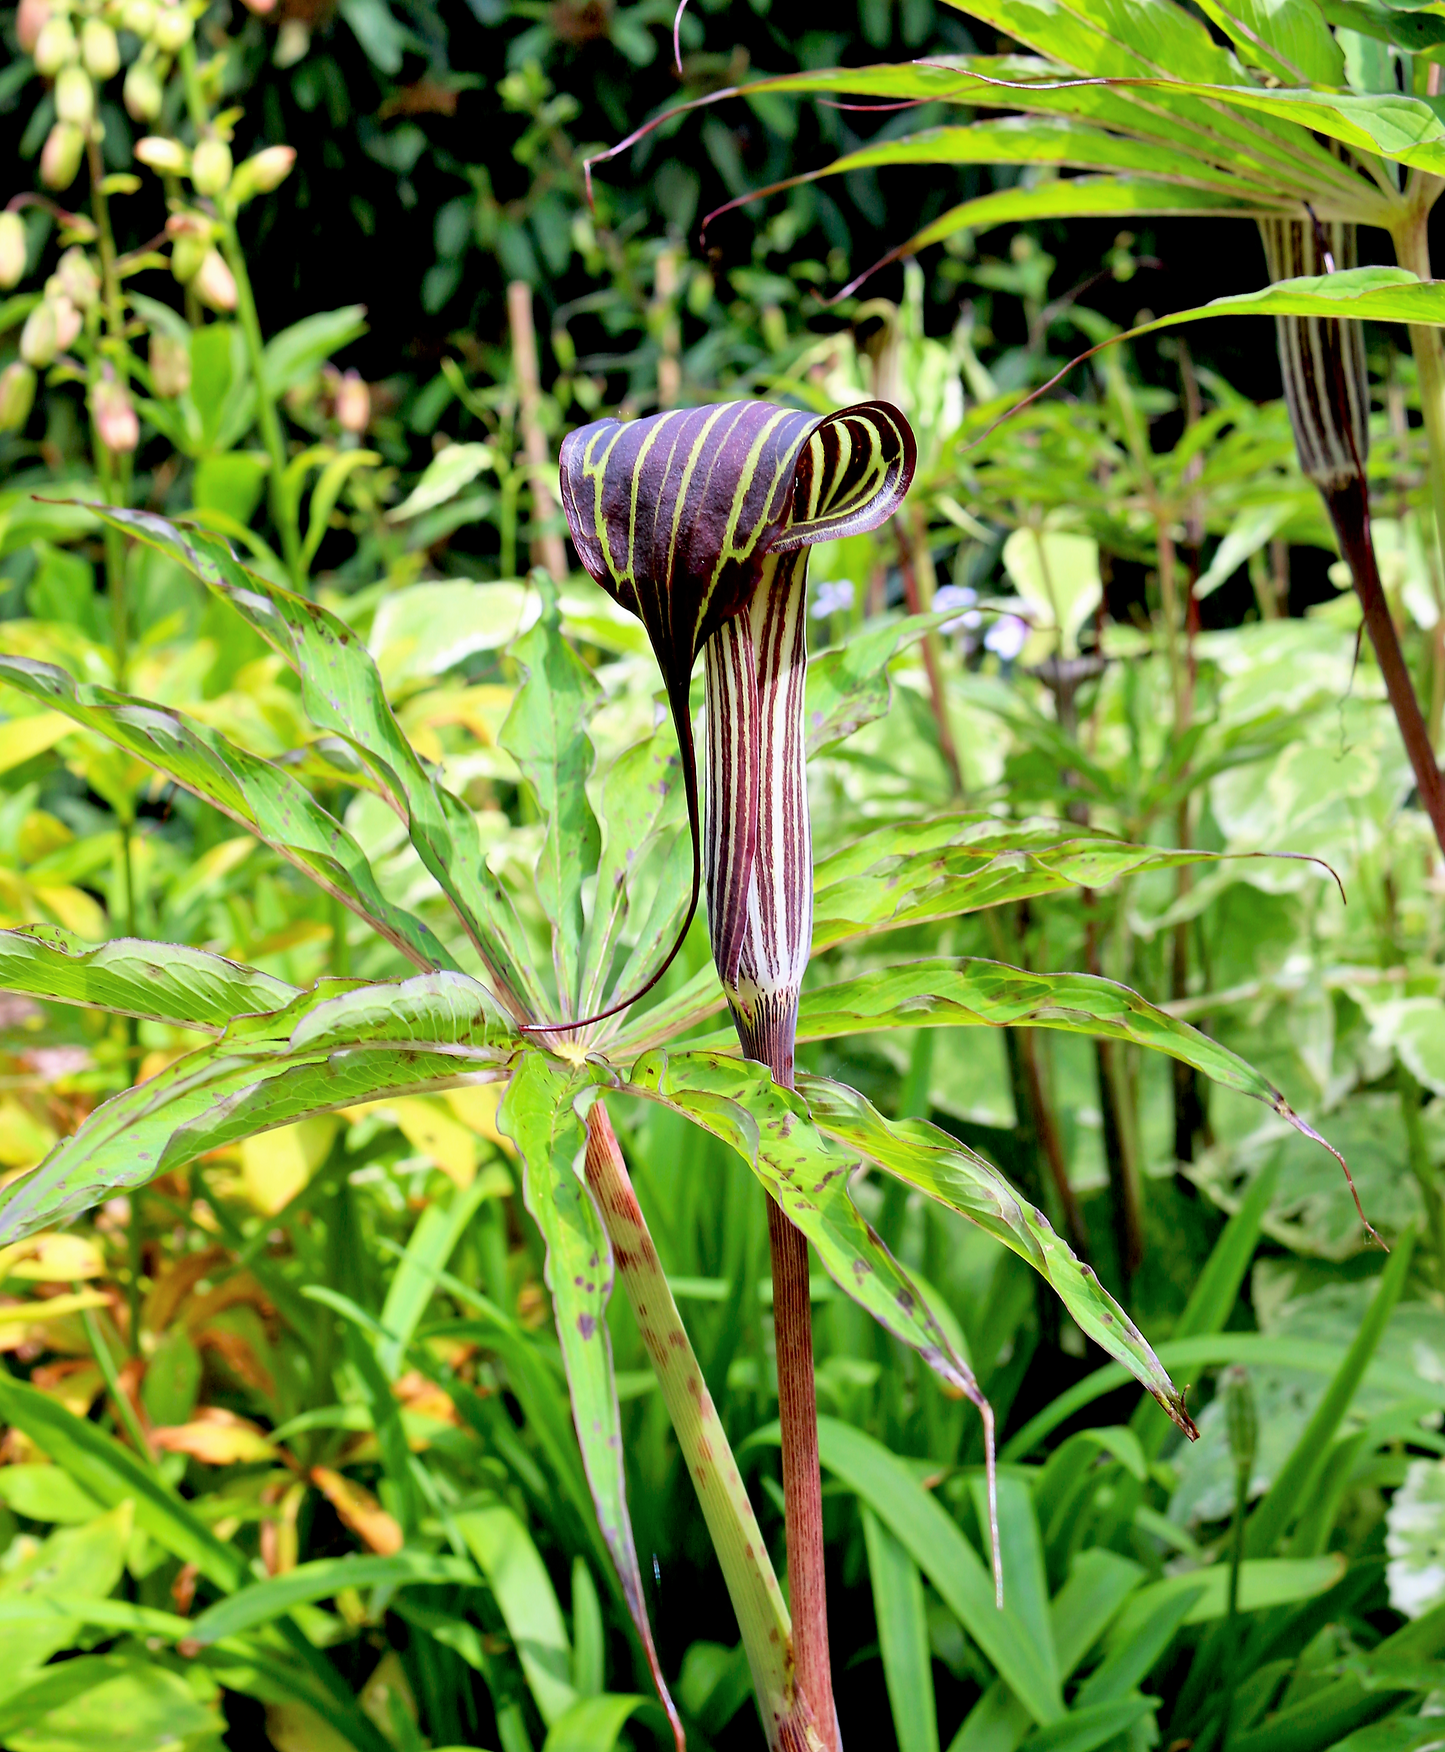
[560,401,916,1747]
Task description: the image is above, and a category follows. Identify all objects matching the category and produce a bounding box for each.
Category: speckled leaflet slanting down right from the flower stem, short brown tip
[795,1072,1195,1433]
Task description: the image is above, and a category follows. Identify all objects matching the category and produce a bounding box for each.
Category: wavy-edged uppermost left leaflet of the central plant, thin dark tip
[85,508,543,1021]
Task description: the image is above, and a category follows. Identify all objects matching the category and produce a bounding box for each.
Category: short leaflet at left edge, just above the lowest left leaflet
[0,925,298,1034]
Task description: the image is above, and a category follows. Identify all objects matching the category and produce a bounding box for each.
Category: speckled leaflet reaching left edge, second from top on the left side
[0,655,455,967]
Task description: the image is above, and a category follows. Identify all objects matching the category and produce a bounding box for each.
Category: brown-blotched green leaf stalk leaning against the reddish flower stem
[585,1100,823,1752]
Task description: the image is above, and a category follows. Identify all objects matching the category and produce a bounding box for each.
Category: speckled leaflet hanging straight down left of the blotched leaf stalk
[497,1051,683,1752]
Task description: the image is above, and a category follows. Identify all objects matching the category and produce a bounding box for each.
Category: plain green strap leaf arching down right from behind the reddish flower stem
[751,1417,1063,1722]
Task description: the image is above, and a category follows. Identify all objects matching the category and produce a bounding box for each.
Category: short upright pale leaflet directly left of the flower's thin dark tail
[576,732,688,1016]
